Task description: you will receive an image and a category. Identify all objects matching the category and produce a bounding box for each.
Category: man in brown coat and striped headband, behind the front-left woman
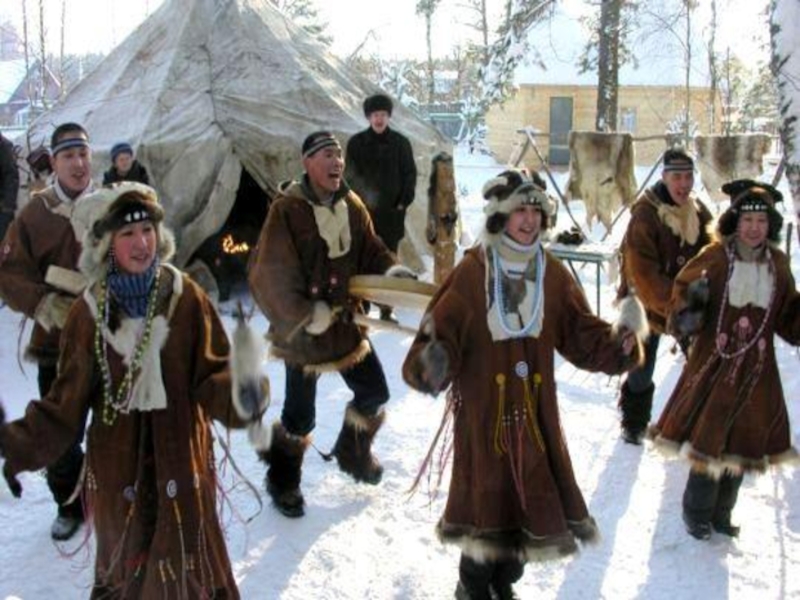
[0,123,94,540]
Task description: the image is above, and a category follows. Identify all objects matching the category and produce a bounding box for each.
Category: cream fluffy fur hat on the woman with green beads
[72,181,175,281]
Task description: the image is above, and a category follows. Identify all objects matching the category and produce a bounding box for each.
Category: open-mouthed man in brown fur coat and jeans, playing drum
[249,131,410,517]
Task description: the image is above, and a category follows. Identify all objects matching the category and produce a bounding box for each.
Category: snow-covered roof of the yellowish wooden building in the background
[515,7,710,87]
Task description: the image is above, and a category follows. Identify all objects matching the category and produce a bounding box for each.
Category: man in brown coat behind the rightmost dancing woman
[618,148,712,444]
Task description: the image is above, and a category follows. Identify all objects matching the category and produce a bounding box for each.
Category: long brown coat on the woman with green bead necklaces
[0,266,244,599]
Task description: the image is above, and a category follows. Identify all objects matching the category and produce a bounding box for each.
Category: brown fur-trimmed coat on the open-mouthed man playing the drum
[248,175,395,372]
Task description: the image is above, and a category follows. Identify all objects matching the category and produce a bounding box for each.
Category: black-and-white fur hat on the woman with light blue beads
[483,169,556,234]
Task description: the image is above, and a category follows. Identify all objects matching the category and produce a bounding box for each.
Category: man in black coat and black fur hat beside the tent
[345,94,417,320]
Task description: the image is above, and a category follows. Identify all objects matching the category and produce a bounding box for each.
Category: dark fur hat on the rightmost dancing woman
[717,179,783,242]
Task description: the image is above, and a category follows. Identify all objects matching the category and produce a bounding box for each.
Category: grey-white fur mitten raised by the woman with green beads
[231,316,270,422]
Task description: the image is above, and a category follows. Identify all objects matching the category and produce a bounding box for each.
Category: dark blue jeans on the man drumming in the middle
[281,349,389,436]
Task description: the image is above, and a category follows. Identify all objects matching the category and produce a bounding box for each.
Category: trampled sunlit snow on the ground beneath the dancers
[0,143,800,600]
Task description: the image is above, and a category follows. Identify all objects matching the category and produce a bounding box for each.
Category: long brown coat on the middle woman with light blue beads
[403,247,644,562]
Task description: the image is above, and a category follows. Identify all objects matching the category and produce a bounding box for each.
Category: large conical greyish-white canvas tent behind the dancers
[23,0,447,290]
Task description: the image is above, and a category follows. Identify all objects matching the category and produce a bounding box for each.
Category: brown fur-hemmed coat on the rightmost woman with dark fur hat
[650,242,800,476]
